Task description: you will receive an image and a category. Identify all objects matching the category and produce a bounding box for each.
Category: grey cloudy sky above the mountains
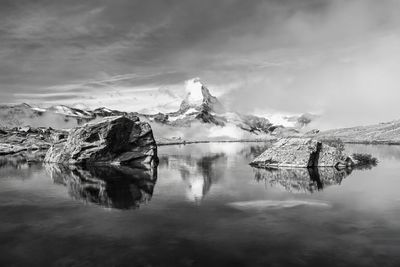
[0,0,400,126]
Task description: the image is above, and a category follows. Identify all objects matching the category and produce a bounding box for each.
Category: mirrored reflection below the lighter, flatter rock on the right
[255,167,351,193]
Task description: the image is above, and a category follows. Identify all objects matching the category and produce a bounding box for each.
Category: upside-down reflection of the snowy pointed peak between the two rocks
[159,153,227,202]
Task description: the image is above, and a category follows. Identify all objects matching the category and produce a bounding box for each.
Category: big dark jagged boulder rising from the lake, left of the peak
[44,116,158,166]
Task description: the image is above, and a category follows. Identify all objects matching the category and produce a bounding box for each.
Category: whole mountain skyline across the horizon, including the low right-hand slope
[0,78,400,144]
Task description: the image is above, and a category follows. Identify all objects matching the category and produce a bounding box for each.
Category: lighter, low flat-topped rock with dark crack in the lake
[250,138,351,168]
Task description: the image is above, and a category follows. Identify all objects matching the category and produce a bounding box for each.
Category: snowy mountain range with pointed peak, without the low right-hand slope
[0,78,314,137]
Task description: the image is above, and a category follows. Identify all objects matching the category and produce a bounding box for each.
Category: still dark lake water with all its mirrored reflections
[0,143,400,266]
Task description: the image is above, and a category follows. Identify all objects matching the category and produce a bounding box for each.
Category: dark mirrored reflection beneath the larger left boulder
[45,164,157,209]
